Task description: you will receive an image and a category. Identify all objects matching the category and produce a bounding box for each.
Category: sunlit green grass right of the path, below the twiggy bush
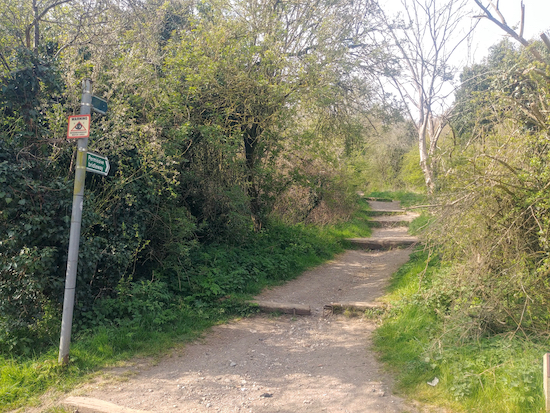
[374,246,548,413]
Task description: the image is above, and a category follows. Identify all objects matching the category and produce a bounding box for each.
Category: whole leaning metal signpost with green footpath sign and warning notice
[58,79,109,365]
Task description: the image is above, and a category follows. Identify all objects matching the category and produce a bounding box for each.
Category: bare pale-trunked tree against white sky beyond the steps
[382,0,473,193]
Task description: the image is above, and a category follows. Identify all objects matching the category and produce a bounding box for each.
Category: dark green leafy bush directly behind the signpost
[0,53,195,354]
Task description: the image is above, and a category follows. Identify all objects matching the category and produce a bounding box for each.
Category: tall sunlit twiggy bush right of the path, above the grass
[429,42,550,336]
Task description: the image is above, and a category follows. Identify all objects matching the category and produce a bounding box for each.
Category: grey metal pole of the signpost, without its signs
[58,79,92,365]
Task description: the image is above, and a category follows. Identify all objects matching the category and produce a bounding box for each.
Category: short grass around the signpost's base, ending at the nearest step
[0,309,220,412]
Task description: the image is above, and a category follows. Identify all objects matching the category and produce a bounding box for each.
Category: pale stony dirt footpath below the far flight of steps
[68,249,417,413]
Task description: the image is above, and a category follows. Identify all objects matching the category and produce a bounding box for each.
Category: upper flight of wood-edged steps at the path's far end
[347,201,418,250]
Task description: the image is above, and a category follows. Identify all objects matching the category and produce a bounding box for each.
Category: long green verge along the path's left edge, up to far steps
[0,201,380,412]
